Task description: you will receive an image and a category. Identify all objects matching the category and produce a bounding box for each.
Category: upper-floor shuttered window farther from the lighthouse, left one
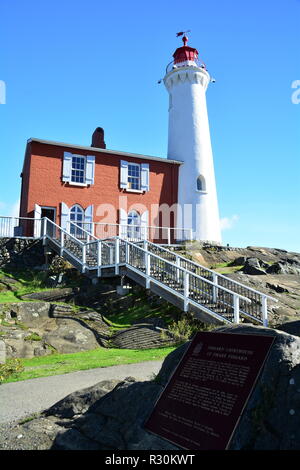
[62,152,95,186]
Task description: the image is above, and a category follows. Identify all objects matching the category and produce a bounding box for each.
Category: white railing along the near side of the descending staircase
[40,221,275,325]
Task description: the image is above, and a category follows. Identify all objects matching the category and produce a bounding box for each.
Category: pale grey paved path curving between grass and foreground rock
[0,361,163,423]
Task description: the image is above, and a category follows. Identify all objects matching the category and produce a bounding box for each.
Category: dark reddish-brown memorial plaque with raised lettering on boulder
[145,332,274,450]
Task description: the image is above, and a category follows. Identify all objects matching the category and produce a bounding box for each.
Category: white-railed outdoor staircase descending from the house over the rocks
[36,218,277,326]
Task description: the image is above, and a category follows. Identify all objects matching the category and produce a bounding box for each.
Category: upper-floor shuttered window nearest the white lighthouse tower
[120,160,149,192]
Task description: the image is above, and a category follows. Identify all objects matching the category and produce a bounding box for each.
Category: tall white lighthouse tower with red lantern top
[164,35,221,244]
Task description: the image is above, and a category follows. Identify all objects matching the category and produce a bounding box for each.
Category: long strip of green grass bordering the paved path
[2,347,176,383]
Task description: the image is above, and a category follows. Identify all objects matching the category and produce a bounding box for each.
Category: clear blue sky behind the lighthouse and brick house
[0,0,300,252]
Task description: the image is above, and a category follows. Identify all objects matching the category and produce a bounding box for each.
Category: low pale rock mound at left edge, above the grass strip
[0,302,109,358]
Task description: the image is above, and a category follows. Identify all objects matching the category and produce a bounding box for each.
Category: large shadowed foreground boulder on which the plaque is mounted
[0,325,300,450]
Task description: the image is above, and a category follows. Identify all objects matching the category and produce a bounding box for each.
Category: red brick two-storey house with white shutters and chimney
[20,128,182,241]
